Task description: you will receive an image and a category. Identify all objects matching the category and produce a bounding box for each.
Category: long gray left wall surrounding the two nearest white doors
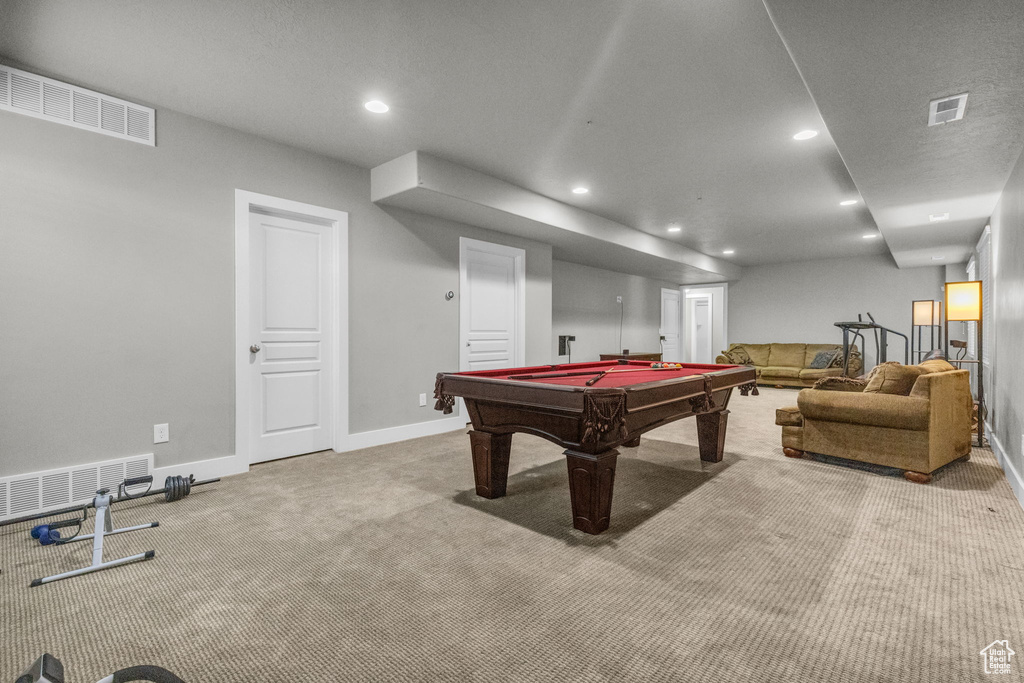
[0,110,551,475]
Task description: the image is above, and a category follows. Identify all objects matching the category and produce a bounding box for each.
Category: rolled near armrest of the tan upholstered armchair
[797,389,931,431]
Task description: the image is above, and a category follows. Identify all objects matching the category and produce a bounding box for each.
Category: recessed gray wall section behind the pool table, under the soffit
[550,261,679,362]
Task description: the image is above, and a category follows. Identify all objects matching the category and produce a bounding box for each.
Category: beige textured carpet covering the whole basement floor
[0,389,1024,683]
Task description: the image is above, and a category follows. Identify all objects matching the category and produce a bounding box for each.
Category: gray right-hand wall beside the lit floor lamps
[982,151,1024,485]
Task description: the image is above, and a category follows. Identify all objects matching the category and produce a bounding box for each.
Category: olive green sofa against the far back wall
[715,344,861,387]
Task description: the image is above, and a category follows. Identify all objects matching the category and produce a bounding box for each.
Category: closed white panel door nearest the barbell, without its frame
[249,212,334,463]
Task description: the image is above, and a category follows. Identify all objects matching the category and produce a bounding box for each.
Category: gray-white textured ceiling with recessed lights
[0,0,1024,274]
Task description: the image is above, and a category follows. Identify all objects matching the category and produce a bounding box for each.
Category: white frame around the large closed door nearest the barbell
[234,189,348,471]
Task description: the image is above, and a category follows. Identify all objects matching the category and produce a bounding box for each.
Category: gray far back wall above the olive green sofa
[729,255,945,368]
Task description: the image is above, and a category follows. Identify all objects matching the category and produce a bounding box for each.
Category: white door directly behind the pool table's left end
[459,238,526,371]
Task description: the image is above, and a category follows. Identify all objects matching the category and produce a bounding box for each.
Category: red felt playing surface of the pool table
[458,360,738,389]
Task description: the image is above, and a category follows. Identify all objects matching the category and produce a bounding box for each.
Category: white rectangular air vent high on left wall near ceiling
[0,65,157,146]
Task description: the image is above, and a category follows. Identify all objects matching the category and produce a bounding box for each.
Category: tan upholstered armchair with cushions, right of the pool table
[775,360,974,483]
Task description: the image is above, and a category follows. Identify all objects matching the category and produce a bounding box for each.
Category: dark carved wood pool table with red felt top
[434,360,758,533]
